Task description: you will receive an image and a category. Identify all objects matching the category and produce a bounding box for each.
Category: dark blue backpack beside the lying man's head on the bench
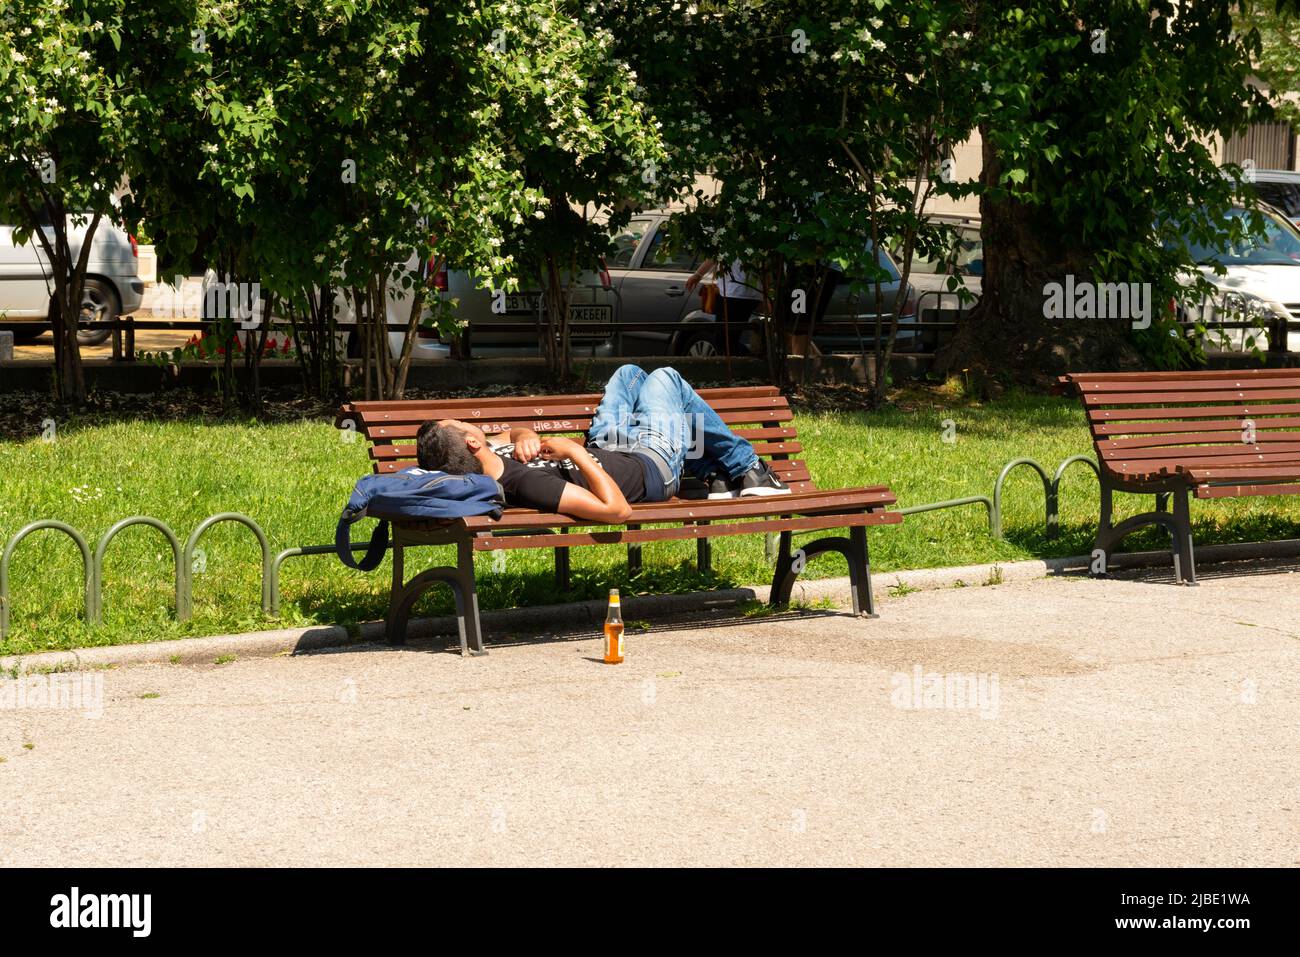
[334,468,506,572]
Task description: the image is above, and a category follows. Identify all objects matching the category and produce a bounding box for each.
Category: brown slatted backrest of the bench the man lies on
[334,386,816,492]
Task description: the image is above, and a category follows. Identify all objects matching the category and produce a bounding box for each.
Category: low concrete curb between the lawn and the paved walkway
[0,538,1300,672]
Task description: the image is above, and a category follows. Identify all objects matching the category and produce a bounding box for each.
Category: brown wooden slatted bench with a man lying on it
[335,386,902,654]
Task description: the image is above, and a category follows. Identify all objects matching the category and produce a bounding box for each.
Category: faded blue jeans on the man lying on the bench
[586,363,758,497]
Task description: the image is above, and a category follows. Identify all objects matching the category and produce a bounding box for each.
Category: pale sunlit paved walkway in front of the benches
[0,572,1300,866]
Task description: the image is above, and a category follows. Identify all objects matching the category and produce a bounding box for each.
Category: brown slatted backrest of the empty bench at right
[1060,369,1300,475]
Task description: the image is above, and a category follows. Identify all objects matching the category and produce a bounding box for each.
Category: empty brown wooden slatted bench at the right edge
[1060,369,1300,585]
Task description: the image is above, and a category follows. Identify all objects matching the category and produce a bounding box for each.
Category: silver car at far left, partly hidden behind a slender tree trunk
[0,216,144,346]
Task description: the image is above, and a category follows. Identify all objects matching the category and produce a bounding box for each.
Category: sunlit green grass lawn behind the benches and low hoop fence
[0,390,1300,654]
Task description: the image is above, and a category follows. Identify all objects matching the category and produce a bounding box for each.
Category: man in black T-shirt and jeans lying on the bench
[416,364,790,524]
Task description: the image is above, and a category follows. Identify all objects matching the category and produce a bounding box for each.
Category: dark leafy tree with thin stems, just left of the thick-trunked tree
[601,0,976,399]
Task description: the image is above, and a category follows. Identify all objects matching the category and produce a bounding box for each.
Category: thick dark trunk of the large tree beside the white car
[935,127,1139,386]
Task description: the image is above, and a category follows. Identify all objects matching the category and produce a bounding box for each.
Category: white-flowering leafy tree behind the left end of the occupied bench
[124,0,536,397]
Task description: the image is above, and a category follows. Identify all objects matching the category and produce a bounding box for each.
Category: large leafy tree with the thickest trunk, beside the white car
[940,0,1268,381]
